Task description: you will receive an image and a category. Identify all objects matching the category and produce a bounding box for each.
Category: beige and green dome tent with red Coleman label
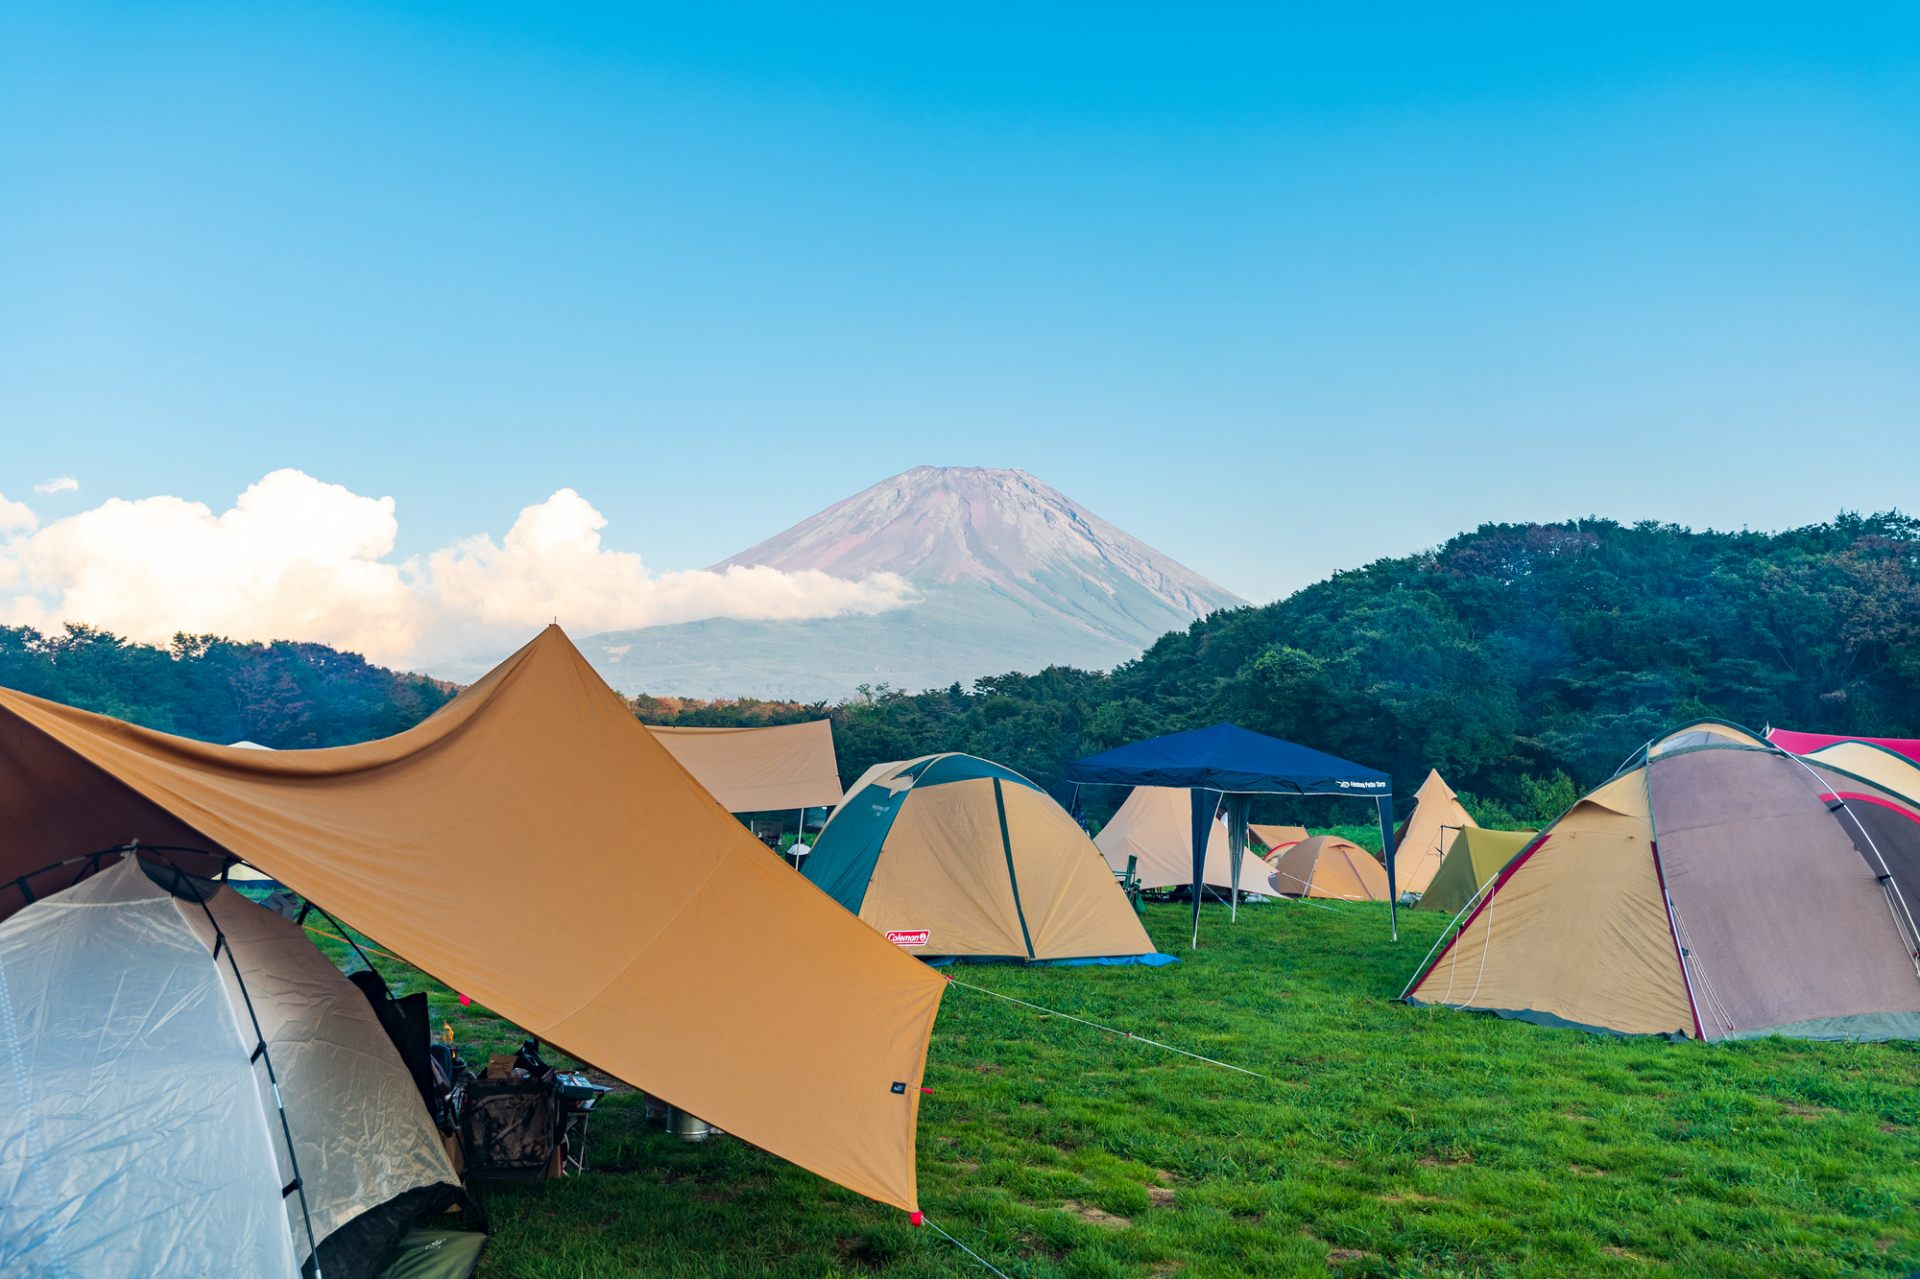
[804,755,1154,960]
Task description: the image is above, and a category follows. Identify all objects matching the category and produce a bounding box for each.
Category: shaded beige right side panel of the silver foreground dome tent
[190,875,459,1260]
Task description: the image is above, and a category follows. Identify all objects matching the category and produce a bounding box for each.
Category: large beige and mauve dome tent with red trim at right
[1407,724,1920,1039]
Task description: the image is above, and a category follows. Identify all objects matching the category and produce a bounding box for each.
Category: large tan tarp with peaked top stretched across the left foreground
[0,628,945,1210]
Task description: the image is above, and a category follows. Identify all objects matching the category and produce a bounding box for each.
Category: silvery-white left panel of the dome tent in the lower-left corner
[0,860,298,1279]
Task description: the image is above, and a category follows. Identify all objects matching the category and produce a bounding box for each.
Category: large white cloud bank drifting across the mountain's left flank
[0,471,912,670]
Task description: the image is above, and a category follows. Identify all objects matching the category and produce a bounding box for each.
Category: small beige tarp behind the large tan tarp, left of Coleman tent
[647,720,839,812]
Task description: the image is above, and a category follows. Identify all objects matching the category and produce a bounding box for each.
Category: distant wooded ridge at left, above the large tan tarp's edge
[0,626,455,751]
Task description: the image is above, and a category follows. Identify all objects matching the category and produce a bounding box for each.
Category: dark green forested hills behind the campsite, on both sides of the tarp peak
[0,513,1920,822]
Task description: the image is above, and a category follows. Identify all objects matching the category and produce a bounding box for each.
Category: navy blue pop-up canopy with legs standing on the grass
[1068,724,1400,945]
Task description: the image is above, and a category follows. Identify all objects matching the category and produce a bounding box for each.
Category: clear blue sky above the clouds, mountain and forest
[0,4,1920,599]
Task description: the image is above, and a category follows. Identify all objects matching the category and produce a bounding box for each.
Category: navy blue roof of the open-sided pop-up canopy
[1068,724,1392,799]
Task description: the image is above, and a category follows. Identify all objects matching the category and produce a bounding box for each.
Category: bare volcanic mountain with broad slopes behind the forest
[582,467,1242,699]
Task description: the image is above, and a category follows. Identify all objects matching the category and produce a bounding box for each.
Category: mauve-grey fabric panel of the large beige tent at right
[1649,749,1920,1039]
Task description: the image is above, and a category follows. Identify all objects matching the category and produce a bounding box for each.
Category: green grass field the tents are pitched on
[318,905,1920,1279]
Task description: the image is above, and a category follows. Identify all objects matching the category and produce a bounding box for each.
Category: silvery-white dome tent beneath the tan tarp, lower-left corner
[0,844,484,1279]
